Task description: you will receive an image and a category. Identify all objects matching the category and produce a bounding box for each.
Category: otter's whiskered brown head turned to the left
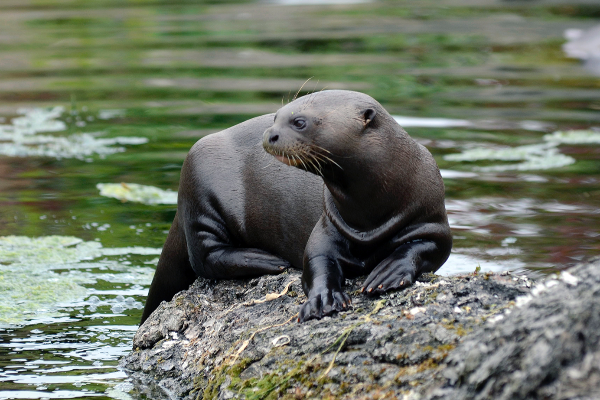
[263,90,381,177]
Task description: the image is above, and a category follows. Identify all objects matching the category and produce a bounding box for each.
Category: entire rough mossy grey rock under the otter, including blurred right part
[121,262,600,400]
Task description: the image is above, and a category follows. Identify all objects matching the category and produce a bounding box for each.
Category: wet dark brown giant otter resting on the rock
[142,90,452,322]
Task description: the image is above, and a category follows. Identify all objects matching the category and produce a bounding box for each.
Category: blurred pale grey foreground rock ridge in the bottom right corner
[427,261,600,400]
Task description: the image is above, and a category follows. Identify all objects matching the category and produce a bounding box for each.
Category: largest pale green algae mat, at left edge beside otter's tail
[0,236,160,326]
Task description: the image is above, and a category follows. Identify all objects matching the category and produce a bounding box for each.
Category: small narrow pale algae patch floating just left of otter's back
[96,183,177,205]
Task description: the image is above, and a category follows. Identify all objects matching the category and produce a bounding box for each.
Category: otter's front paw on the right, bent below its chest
[361,263,416,296]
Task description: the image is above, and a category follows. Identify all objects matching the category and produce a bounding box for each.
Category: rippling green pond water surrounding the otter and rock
[0,0,600,399]
